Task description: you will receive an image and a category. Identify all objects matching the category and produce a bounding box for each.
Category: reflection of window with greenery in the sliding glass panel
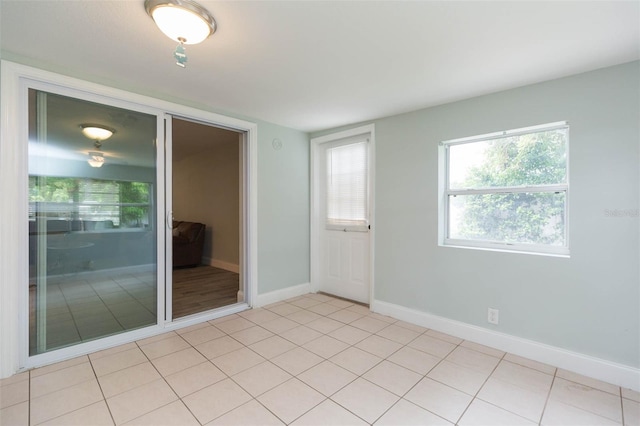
[29,176,151,230]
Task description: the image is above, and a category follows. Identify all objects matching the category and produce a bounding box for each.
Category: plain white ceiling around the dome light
[0,0,640,132]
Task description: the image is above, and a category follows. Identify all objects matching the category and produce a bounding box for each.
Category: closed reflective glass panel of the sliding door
[28,89,158,356]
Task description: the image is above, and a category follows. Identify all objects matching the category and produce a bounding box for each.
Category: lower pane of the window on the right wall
[449,192,566,246]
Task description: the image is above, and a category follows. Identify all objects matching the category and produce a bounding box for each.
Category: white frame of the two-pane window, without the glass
[438,121,570,257]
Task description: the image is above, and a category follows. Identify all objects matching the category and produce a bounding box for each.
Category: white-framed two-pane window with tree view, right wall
[440,122,569,255]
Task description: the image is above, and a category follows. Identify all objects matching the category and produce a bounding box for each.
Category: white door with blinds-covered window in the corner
[312,126,372,303]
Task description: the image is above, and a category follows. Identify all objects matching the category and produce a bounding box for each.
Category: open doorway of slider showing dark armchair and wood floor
[167,117,245,320]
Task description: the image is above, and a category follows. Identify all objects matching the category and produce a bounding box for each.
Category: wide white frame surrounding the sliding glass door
[0,60,258,378]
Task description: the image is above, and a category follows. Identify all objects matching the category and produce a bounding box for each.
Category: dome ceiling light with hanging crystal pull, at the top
[144,0,216,68]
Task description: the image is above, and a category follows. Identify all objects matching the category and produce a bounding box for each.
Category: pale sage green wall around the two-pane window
[314,62,640,367]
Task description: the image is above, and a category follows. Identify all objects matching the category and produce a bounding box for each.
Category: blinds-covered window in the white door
[327,139,369,231]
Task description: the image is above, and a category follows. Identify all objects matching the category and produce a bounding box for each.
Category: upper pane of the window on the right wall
[449,128,568,189]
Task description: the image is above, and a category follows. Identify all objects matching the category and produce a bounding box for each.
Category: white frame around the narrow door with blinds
[310,124,376,305]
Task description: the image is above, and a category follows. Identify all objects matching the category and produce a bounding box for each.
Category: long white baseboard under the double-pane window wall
[371,300,640,391]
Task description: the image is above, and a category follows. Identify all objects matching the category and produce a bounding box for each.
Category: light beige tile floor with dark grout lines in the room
[0,294,640,426]
